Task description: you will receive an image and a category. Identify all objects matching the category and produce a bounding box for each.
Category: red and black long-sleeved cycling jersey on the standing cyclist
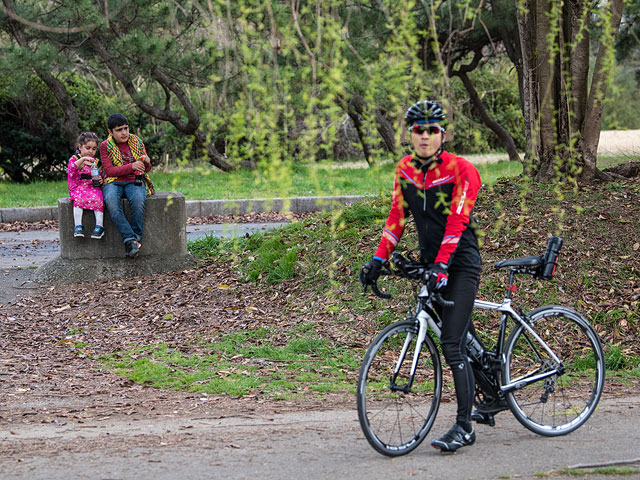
[374,152,481,271]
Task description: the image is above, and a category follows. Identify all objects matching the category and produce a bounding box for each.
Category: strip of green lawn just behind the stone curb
[0,161,522,208]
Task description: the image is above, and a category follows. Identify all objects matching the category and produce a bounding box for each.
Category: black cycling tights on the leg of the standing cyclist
[438,271,479,428]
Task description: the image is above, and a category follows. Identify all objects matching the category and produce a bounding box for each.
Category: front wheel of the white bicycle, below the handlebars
[357,320,442,457]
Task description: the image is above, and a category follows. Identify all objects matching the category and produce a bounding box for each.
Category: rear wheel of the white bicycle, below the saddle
[503,305,605,437]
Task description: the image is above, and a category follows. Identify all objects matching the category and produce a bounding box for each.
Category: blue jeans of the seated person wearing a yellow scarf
[102,182,147,243]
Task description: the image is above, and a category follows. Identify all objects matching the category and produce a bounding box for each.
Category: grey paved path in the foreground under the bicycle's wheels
[0,396,640,480]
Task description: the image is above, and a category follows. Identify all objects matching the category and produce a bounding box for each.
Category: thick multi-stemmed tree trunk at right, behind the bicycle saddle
[516,0,624,183]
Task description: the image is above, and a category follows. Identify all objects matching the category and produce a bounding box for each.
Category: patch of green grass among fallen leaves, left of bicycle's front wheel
[100,324,362,399]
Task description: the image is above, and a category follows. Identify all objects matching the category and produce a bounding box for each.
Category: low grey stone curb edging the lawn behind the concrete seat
[0,195,375,223]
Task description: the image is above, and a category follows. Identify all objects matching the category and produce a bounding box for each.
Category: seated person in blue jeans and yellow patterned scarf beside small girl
[100,113,151,258]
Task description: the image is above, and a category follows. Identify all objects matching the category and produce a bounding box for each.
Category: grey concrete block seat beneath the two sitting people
[34,192,196,284]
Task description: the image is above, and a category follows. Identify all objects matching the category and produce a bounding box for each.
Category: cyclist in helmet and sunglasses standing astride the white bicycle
[360,100,481,452]
